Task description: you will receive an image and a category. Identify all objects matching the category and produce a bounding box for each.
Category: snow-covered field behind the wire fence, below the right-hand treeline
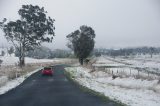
[95,55,160,69]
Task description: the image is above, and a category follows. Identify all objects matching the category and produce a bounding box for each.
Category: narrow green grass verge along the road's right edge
[64,70,126,106]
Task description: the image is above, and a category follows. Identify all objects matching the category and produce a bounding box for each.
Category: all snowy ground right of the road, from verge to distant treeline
[63,56,160,106]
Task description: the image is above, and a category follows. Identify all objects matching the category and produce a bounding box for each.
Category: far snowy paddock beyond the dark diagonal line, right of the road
[102,55,160,73]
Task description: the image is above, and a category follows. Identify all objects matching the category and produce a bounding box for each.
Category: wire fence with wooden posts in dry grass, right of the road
[92,66,160,80]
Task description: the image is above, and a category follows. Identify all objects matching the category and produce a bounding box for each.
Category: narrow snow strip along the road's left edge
[0,68,41,95]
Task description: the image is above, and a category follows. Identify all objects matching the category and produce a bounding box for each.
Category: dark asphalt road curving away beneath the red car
[0,65,119,106]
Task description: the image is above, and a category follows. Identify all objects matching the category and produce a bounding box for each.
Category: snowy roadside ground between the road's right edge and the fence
[66,67,160,106]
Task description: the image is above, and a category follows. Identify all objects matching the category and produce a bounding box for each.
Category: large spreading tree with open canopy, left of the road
[0,5,55,67]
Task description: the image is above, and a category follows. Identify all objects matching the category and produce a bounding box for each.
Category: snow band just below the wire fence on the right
[97,77,160,93]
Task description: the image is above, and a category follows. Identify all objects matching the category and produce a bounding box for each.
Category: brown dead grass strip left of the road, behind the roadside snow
[0,59,77,80]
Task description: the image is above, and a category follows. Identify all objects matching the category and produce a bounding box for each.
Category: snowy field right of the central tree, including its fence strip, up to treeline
[93,56,160,79]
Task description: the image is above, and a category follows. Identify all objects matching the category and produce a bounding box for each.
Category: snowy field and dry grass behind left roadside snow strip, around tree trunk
[0,55,76,79]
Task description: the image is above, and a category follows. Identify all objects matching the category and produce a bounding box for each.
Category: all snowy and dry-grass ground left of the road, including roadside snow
[0,55,77,94]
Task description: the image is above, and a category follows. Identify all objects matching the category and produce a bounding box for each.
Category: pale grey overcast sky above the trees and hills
[0,0,160,49]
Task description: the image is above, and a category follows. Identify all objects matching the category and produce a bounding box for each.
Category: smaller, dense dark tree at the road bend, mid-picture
[67,25,95,65]
